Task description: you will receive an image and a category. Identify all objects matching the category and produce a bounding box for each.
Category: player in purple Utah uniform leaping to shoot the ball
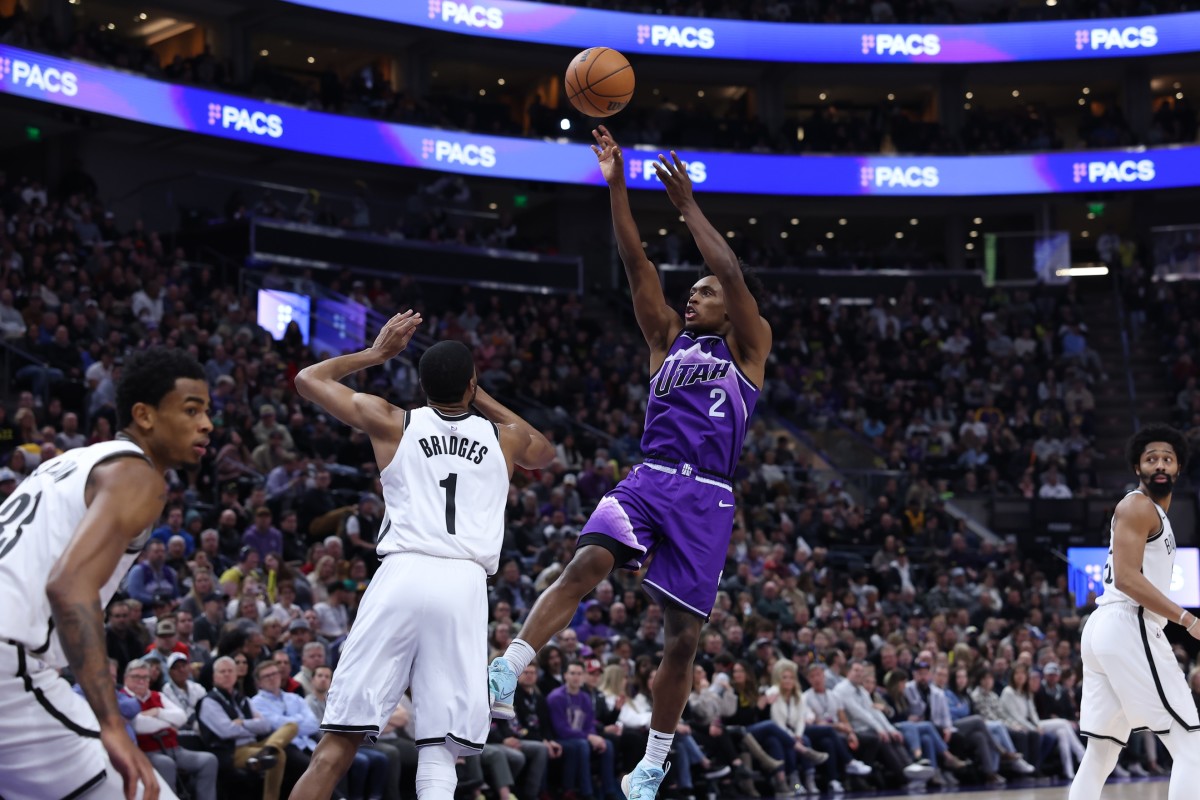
[488,126,772,800]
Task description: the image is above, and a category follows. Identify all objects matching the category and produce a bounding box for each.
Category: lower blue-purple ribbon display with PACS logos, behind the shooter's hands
[0,46,1200,197]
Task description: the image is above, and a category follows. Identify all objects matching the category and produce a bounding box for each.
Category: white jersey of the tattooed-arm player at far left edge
[0,439,151,667]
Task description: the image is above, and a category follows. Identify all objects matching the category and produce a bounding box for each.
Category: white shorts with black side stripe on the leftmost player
[0,642,175,800]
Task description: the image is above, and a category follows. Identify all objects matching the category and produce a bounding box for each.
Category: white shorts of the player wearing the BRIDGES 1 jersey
[320,553,491,756]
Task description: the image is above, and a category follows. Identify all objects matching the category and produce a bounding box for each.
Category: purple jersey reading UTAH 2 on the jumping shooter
[642,330,758,476]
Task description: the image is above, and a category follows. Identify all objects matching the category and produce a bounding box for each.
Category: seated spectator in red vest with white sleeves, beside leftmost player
[121,658,217,800]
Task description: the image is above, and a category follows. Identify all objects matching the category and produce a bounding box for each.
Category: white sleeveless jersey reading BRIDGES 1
[377,407,509,575]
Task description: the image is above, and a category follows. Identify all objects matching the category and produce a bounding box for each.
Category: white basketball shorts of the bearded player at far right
[1079,603,1200,746]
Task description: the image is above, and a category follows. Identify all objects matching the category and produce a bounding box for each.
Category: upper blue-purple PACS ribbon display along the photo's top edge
[288,0,1200,66]
